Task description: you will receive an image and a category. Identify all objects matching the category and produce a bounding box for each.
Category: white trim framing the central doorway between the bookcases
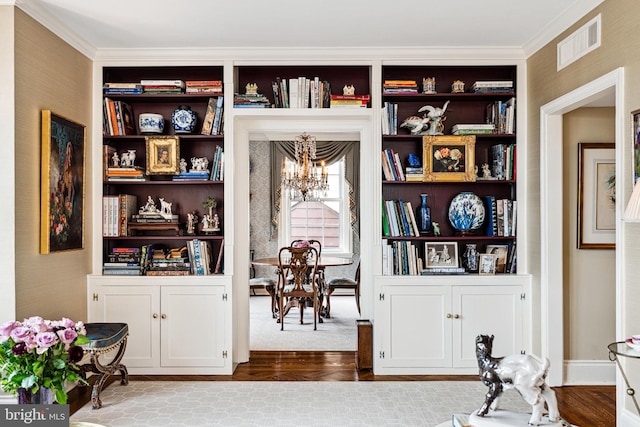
[232,109,380,364]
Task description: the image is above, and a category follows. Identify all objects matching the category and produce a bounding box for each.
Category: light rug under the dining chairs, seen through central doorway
[249,295,360,351]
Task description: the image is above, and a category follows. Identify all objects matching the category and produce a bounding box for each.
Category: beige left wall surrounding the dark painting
[15,9,92,320]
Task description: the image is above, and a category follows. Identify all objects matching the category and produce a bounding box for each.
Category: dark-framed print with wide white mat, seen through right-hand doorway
[578,142,616,249]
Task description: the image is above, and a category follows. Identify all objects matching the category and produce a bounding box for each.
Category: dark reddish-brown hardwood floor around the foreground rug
[69,351,616,427]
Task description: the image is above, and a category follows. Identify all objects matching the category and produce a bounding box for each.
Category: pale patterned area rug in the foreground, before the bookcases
[71,381,530,427]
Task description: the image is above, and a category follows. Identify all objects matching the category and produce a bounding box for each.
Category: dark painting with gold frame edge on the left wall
[40,110,86,254]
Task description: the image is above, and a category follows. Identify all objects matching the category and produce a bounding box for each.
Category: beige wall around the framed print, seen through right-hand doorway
[563,108,616,360]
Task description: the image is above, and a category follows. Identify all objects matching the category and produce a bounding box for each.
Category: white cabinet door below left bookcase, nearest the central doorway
[160,285,226,367]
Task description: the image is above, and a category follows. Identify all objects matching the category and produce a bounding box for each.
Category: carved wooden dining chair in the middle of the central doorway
[278,246,322,331]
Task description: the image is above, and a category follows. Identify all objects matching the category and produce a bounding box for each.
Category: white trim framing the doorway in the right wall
[540,68,630,386]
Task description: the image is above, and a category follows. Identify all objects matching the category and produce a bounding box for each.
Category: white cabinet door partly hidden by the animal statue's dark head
[452,285,524,368]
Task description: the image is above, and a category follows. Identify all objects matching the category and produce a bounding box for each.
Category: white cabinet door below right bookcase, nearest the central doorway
[376,285,451,368]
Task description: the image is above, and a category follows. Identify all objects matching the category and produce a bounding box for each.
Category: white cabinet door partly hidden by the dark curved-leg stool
[88,279,160,368]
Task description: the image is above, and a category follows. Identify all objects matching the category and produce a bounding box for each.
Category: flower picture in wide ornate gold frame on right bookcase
[422,135,476,182]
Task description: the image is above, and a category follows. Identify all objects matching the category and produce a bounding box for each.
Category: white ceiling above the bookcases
[8,0,603,56]
